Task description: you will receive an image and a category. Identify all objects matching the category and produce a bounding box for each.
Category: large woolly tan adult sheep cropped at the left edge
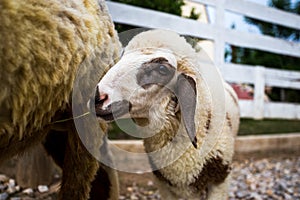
[0,0,121,200]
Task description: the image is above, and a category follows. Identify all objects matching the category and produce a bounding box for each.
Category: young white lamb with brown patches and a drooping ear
[92,30,239,199]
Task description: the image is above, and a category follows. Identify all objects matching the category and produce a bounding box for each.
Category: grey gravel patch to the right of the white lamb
[229,157,300,200]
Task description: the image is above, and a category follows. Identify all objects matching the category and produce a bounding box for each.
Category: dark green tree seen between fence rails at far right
[225,0,300,102]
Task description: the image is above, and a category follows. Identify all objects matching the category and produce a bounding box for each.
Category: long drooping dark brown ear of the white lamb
[176,74,197,148]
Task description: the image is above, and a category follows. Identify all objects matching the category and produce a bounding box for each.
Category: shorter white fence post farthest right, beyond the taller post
[254,66,265,120]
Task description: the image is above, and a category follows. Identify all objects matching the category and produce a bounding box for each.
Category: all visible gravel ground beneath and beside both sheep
[0,157,300,200]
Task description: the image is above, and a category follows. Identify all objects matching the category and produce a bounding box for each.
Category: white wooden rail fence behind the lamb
[107,0,300,119]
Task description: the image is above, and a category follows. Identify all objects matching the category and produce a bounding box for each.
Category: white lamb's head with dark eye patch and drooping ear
[91,30,209,147]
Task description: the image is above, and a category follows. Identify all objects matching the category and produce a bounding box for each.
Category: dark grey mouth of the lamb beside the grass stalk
[95,100,132,121]
